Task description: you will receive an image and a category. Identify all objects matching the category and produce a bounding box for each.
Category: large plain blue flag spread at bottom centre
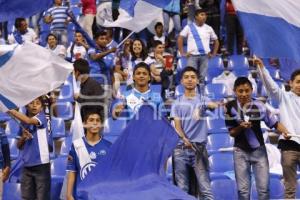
[77,106,194,200]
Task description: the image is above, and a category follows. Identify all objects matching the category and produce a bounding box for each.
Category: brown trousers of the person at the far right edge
[281,151,300,199]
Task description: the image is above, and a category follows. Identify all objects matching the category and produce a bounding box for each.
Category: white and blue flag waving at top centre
[103,0,171,32]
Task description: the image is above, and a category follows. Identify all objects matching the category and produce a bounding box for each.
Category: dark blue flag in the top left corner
[0,0,53,22]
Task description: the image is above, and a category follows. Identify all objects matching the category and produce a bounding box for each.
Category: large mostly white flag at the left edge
[0,42,73,112]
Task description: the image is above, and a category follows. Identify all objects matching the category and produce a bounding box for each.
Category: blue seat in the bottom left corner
[2,182,21,200]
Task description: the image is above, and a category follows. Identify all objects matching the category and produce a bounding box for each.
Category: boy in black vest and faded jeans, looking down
[225,77,288,199]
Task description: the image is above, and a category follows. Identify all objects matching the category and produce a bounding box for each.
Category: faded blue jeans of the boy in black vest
[234,146,269,200]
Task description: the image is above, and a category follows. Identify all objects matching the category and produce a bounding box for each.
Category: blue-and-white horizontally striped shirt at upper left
[45,6,71,31]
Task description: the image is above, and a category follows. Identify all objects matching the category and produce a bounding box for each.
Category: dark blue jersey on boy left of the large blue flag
[67,137,111,196]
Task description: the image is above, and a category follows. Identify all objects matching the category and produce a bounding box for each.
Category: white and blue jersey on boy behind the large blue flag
[115,88,163,119]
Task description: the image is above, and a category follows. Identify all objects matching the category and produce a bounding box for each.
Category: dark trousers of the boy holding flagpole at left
[21,163,51,200]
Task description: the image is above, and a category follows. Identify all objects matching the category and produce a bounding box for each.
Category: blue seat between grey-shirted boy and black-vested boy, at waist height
[206,133,233,154]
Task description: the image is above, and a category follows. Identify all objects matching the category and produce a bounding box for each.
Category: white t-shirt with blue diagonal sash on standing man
[180,23,218,55]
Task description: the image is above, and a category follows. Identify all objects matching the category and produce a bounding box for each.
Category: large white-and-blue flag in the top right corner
[232,0,300,60]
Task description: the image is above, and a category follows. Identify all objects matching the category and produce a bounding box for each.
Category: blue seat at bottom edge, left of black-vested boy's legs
[211,179,238,200]
